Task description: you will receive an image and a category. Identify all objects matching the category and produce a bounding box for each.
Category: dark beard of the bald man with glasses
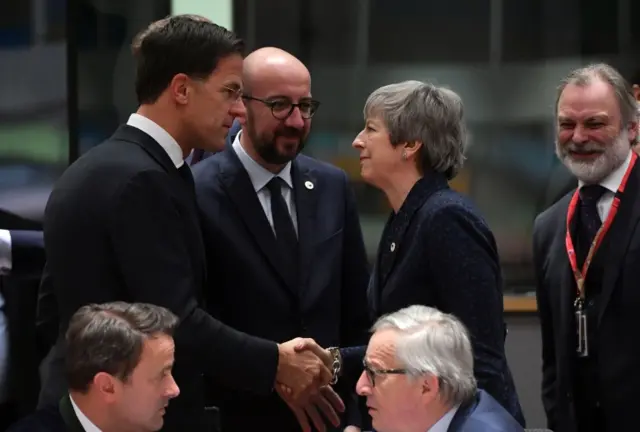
[245,112,307,165]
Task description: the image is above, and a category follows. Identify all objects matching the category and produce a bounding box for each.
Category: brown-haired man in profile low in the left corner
[11,302,180,432]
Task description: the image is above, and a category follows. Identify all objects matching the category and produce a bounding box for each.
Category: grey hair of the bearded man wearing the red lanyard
[555,63,638,143]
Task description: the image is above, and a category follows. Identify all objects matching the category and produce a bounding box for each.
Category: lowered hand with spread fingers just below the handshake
[276,384,345,432]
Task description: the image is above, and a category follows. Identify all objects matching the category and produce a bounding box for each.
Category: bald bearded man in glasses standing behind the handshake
[194,48,369,432]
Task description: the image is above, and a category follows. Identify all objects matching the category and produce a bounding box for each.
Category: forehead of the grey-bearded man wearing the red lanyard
[558,78,620,119]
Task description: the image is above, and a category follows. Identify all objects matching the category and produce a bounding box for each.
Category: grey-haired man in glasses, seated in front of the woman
[357,305,523,432]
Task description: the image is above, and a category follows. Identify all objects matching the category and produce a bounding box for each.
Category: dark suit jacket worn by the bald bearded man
[194,128,369,431]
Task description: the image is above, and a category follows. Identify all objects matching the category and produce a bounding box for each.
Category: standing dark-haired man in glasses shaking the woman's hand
[41,15,331,431]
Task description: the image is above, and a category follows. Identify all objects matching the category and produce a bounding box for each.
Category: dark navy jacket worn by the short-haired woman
[369,173,524,425]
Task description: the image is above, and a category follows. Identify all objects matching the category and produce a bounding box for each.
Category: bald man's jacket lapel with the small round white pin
[291,158,321,294]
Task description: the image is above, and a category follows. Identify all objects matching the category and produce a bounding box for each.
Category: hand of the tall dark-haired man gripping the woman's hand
[276,338,332,406]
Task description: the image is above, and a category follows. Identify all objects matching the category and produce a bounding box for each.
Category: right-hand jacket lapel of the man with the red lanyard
[587,162,640,324]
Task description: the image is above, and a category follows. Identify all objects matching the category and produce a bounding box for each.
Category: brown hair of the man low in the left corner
[65,302,178,392]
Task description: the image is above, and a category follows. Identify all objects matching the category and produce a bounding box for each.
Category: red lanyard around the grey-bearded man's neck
[565,151,638,300]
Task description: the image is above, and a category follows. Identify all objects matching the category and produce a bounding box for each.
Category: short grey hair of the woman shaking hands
[364,81,467,180]
